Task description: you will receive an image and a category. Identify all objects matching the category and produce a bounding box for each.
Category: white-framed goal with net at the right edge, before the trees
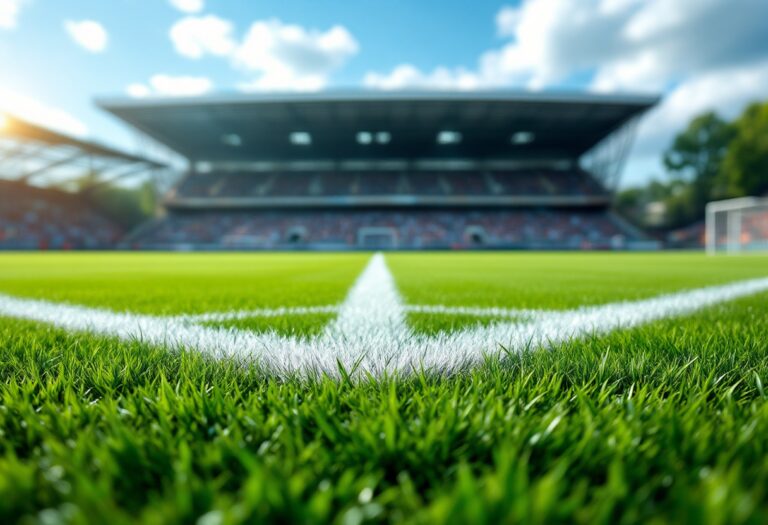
[706,197,768,254]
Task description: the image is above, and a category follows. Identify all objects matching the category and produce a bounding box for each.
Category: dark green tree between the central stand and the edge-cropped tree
[663,112,735,221]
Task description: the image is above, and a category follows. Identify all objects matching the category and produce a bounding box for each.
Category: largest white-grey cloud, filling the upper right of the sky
[367,0,768,91]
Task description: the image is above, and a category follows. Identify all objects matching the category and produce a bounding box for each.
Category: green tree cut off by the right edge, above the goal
[723,103,768,196]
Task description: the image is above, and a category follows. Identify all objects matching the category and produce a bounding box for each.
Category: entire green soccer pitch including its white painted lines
[0,253,768,524]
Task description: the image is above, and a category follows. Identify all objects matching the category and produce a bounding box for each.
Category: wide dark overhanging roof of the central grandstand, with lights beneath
[98,91,658,161]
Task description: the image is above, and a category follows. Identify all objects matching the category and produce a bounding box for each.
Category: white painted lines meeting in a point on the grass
[0,254,768,376]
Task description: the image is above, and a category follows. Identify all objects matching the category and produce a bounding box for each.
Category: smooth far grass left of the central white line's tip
[0,253,369,314]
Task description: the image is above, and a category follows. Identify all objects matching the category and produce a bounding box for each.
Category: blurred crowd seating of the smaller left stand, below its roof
[0,180,123,250]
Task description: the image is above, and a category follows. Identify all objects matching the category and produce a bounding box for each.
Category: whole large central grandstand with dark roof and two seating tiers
[99,91,657,249]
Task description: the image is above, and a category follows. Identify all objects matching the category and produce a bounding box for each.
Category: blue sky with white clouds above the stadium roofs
[0,0,768,184]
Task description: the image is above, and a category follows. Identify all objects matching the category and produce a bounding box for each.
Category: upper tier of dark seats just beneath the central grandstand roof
[175,170,605,198]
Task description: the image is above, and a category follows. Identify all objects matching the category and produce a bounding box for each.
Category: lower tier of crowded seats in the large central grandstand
[135,209,628,248]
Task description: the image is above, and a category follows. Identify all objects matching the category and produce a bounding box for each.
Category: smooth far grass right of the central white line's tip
[387,252,768,308]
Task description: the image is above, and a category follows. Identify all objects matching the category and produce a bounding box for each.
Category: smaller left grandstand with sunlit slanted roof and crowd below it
[0,115,163,250]
